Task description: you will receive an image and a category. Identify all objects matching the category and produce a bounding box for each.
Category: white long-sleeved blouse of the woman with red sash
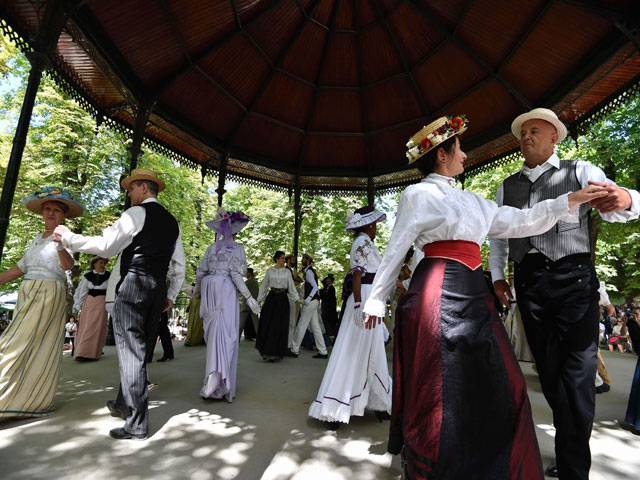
[364,173,572,317]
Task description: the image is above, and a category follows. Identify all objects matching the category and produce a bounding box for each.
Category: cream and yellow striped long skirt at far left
[0,280,67,418]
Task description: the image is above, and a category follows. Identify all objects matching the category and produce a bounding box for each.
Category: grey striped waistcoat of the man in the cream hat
[503,160,591,262]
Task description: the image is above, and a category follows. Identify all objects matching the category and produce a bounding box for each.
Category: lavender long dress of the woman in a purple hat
[196,242,251,402]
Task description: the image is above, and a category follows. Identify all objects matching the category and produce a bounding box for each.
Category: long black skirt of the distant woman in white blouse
[256,289,289,357]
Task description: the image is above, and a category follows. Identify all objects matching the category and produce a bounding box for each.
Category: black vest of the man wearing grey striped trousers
[120,202,179,281]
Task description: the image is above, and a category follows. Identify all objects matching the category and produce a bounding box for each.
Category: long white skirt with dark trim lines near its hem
[309,284,391,423]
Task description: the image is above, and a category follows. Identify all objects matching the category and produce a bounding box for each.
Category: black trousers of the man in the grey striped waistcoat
[514,254,599,480]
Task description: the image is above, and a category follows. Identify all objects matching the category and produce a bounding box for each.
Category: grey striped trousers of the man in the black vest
[113,272,167,435]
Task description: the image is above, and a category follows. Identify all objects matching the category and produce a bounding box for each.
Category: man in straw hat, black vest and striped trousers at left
[54,168,185,440]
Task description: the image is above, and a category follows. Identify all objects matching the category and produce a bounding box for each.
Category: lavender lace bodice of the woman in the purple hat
[195,242,251,298]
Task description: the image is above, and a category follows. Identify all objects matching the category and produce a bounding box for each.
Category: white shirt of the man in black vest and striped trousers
[62,198,186,302]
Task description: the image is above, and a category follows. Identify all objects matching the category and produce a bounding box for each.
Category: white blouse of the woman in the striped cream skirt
[17,234,73,285]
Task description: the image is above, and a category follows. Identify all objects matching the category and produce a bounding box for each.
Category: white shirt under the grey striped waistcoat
[489,153,640,282]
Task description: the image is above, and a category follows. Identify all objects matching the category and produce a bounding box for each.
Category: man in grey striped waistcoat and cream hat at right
[489,108,640,480]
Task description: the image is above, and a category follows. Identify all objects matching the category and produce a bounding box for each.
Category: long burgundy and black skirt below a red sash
[389,258,544,480]
